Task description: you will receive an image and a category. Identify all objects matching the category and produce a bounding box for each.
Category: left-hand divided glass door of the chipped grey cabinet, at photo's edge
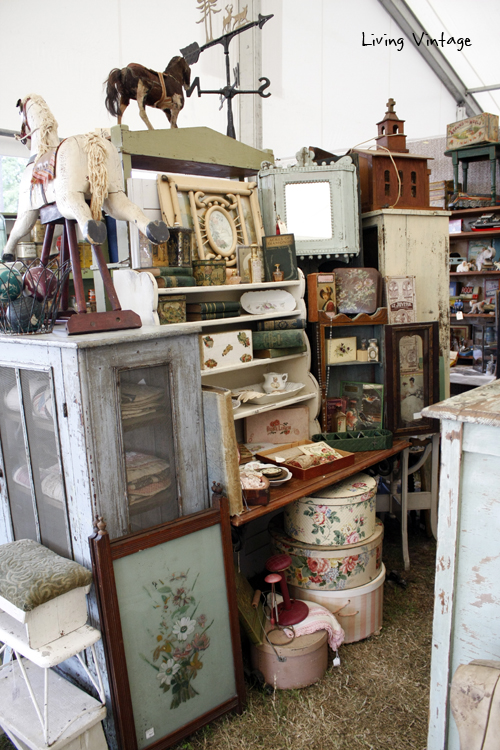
[0,367,72,557]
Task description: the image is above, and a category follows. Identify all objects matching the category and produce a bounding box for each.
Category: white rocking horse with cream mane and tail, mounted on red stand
[3,94,169,261]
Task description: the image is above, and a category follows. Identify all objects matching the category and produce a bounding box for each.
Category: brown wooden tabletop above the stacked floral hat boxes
[231,439,410,526]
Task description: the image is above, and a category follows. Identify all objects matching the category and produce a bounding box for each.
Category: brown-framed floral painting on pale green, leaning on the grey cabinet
[90,499,244,750]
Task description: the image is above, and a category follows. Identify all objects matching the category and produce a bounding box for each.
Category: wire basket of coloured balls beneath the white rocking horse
[0,258,71,335]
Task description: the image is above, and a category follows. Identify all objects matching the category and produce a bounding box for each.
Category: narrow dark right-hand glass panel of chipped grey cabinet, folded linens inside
[118,365,183,532]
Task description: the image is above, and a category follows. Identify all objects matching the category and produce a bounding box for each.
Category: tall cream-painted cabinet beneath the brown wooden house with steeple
[362,208,450,397]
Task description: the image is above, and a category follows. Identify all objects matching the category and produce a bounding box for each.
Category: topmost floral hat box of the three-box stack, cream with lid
[285,474,377,546]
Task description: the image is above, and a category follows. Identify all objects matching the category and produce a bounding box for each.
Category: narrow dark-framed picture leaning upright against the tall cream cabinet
[385,321,439,437]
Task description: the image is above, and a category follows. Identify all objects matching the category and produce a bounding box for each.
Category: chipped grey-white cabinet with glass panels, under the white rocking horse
[0,324,208,567]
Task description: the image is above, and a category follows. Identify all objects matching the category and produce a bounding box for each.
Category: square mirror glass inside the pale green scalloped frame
[285,180,332,240]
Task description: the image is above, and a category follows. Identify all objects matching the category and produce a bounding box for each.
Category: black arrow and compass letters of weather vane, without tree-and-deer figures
[181,13,273,139]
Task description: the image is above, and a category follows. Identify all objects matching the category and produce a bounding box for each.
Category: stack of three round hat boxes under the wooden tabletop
[269,474,385,643]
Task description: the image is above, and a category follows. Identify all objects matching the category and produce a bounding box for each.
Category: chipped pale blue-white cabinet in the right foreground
[423,380,500,750]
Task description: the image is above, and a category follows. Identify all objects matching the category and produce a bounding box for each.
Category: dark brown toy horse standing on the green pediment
[104,56,191,130]
